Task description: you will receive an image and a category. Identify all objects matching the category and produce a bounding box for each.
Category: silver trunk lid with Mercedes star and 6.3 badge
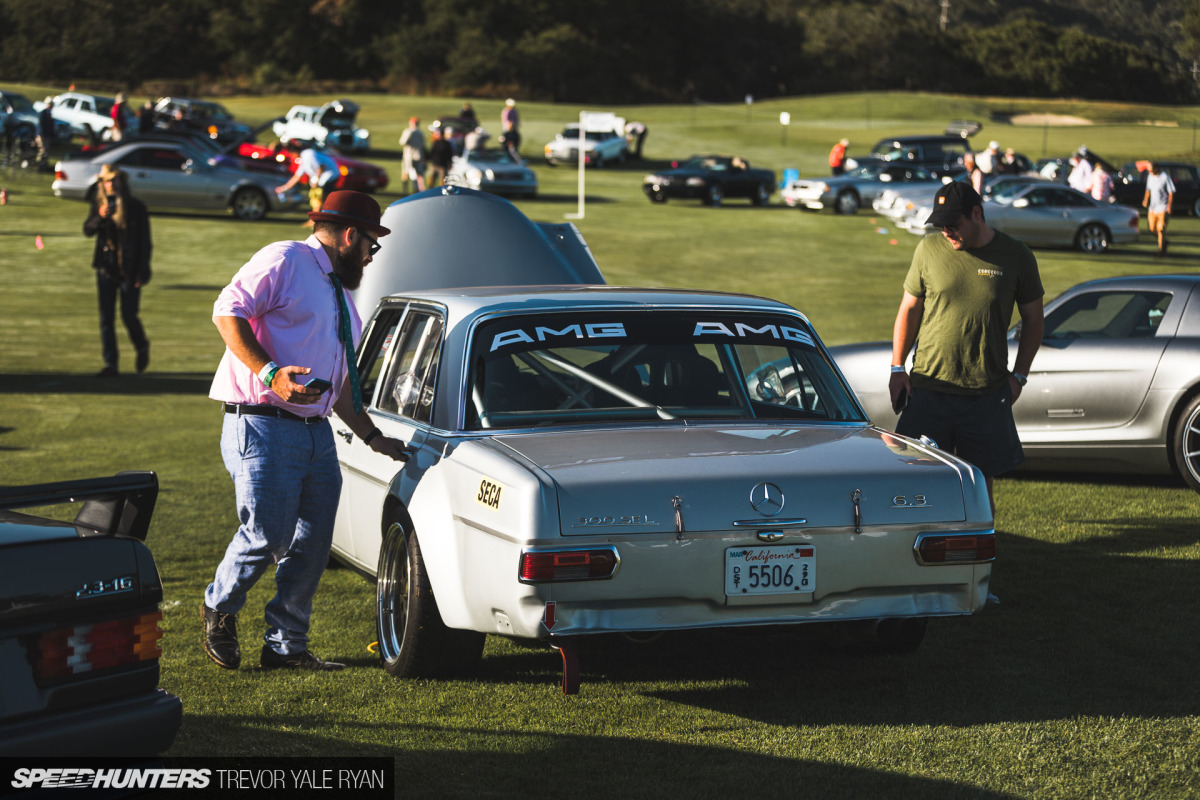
[496,426,972,535]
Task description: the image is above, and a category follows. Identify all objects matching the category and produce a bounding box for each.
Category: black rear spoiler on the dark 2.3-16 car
[0,471,158,541]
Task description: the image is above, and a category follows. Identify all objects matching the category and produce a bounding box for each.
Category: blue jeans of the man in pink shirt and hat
[204,414,342,655]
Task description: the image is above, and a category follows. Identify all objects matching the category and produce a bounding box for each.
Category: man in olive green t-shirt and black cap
[889,181,1044,513]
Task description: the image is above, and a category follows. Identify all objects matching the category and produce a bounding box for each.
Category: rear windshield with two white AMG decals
[467,309,862,429]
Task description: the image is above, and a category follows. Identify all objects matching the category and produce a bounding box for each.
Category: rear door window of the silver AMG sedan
[379,311,442,422]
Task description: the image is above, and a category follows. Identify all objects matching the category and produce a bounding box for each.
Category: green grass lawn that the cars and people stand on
[0,86,1200,800]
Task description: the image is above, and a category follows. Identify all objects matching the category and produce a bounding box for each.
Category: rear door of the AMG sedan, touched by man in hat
[334,306,443,569]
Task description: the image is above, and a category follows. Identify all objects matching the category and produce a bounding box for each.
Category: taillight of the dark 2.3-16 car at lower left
[30,612,162,681]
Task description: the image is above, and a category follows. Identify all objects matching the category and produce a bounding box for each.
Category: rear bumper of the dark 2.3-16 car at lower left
[0,688,184,757]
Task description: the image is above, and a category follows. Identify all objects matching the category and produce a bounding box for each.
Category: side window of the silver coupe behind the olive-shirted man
[1045,291,1171,339]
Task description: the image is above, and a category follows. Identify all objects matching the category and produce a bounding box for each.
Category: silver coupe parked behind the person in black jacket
[52,139,306,221]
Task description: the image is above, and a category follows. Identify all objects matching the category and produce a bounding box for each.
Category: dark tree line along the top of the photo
[0,0,1200,104]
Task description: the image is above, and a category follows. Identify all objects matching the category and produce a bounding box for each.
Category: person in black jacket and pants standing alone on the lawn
[83,164,152,378]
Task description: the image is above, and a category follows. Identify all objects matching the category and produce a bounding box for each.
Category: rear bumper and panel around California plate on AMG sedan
[453,528,991,638]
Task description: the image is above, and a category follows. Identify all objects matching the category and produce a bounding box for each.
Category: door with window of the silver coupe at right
[1009,289,1186,440]
